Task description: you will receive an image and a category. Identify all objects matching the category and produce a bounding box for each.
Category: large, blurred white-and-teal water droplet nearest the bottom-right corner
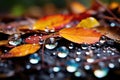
[94,68,109,78]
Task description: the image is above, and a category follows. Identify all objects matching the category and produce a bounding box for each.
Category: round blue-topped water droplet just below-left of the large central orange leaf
[57,46,69,58]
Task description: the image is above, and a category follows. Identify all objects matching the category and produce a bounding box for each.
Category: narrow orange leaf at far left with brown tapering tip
[0,44,40,58]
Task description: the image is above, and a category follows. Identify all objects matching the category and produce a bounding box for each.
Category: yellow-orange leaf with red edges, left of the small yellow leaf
[33,14,73,30]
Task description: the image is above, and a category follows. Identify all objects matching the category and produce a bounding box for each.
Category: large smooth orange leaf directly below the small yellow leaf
[59,27,102,44]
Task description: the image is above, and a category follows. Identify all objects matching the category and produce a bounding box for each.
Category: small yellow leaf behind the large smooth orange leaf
[77,17,100,28]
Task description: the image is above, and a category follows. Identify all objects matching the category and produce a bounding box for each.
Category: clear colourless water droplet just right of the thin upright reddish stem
[45,38,58,49]
